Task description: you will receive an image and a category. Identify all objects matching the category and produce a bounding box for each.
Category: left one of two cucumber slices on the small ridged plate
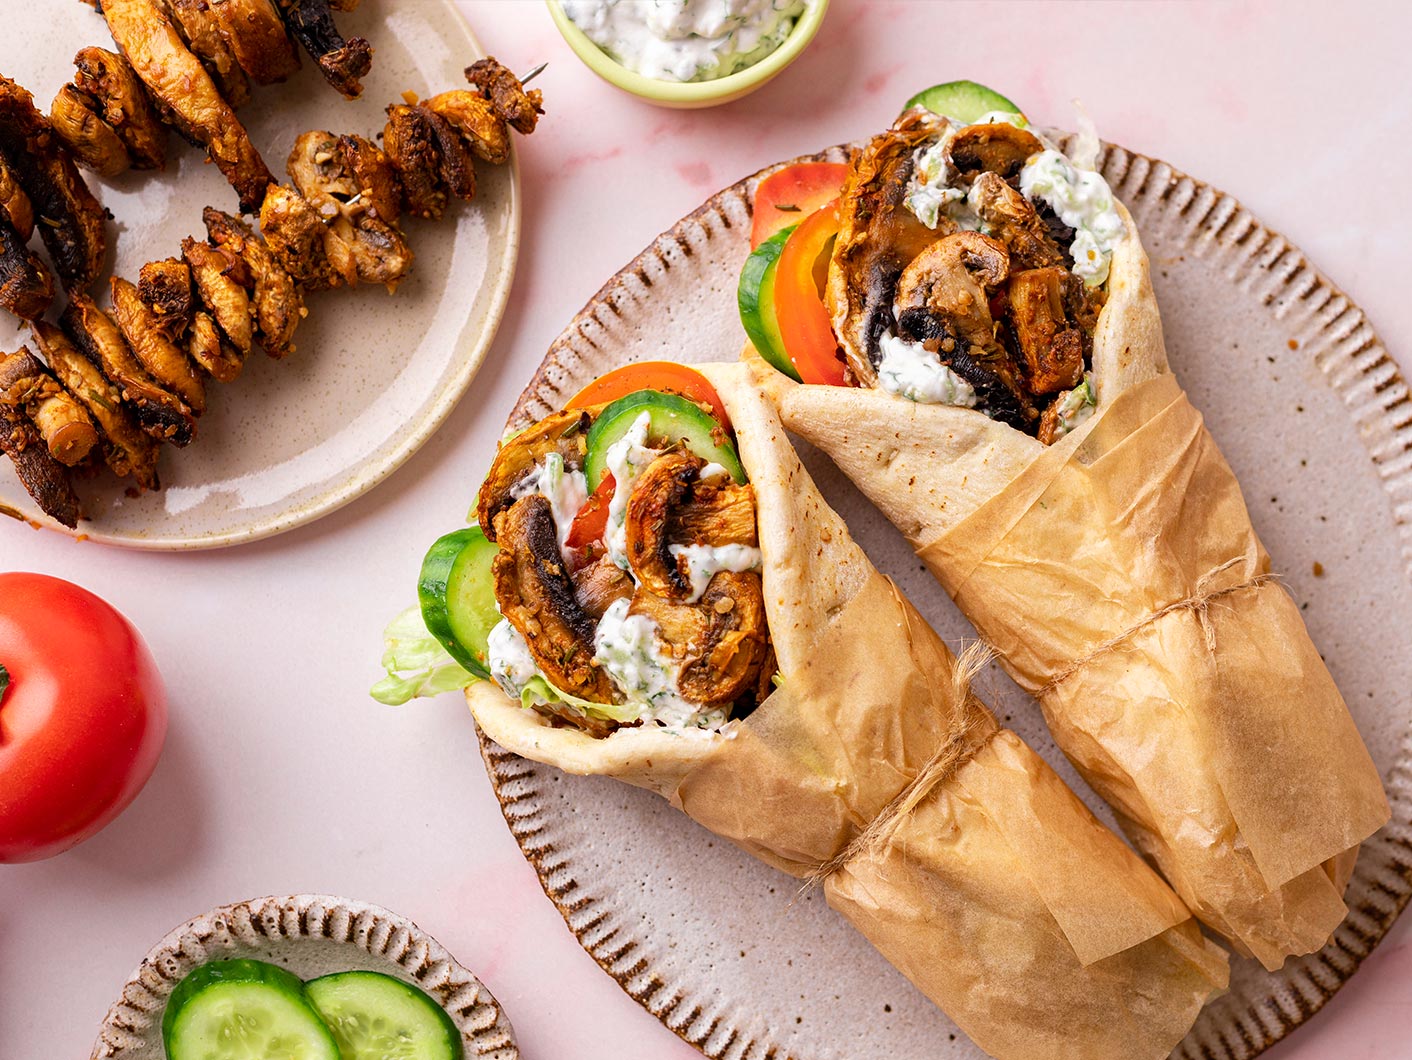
[162,960,340,1060]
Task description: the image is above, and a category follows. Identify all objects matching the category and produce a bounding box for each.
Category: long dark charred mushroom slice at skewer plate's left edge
[0,76,107,288]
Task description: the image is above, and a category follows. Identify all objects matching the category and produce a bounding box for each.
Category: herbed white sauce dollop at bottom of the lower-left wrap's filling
[593,600,726,728]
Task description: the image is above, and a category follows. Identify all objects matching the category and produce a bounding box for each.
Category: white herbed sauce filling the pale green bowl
[563,0,808,82]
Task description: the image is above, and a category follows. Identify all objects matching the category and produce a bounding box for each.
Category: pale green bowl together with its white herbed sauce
[548,0,829,107]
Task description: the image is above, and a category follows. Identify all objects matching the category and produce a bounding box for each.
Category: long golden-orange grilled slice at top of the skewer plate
[103,0,274,212]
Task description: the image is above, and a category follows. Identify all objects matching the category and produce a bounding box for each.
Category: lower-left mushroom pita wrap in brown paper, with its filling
[372,363,1227,1060]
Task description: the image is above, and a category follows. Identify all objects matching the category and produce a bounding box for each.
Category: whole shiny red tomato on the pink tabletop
[0,573,167,861]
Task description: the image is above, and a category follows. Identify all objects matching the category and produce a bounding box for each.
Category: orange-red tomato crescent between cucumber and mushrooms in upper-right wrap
[775,199,846,387]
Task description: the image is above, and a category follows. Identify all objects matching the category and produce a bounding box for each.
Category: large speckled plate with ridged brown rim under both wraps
[483,148,1412,1060]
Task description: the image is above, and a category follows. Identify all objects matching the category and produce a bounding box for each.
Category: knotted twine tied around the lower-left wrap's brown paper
[796,641,1000,898]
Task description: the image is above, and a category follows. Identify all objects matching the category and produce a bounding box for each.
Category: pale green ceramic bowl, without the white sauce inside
[546,0,829,107]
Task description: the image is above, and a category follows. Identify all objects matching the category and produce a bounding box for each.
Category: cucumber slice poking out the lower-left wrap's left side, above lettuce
[417,526,500,677]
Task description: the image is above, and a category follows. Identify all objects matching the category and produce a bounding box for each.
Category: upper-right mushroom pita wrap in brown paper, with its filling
[741,82,1389,968]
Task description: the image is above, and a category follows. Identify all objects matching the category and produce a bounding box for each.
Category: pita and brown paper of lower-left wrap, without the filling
[466,364,1227,1060]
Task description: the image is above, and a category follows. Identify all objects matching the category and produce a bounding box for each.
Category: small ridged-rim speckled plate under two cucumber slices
[92,895,520,1060]
